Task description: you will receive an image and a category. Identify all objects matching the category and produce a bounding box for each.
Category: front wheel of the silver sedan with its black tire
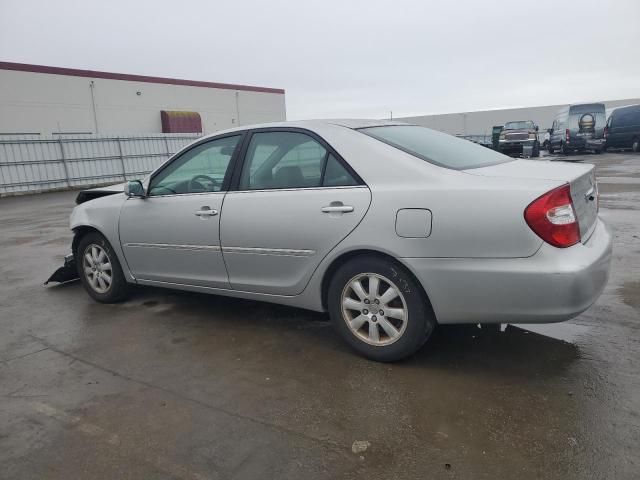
[75,232,131,303]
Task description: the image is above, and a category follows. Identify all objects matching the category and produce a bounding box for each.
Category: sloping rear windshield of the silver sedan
[359,125,511,170]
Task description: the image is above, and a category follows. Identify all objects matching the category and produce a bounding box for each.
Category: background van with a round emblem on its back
[549,103,606,155]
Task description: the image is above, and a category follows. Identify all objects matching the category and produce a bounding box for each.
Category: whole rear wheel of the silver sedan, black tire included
[327,255,437,362]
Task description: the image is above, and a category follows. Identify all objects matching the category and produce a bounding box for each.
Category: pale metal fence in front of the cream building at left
[0,133,200,196]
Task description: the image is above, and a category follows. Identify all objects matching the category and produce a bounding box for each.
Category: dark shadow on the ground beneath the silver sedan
[112,287,580,376]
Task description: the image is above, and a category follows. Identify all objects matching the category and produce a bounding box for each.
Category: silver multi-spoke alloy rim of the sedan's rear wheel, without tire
[341,273,409,346]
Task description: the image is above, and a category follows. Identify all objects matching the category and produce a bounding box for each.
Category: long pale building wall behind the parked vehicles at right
[395,98,640,135]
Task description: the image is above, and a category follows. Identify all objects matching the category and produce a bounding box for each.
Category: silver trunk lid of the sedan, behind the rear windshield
[465,160,598,243]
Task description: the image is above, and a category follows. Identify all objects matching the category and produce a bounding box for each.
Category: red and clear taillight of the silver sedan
[524,184,580,248]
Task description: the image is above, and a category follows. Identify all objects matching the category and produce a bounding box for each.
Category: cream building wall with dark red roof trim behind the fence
[0,69,286,134]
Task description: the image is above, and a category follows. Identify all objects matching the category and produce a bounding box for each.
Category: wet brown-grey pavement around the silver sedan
[0,153,640,480]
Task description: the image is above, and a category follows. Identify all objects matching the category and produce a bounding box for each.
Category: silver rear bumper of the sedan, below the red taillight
[401,219,612,324]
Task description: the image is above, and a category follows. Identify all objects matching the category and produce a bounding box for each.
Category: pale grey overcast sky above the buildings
[0,0,640,119]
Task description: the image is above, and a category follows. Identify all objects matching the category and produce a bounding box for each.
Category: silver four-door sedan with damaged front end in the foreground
[55,120,611,361]
